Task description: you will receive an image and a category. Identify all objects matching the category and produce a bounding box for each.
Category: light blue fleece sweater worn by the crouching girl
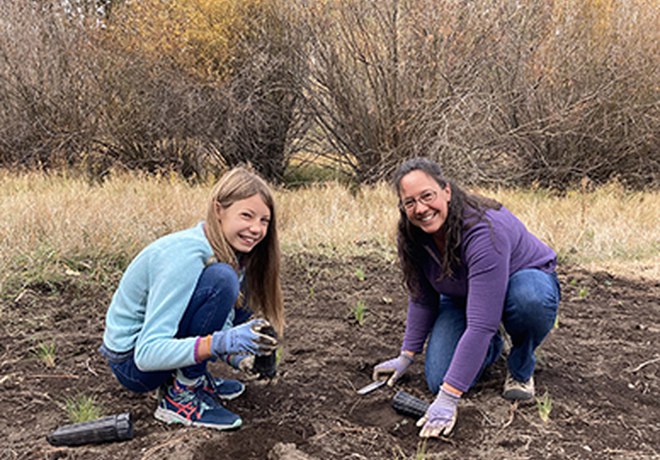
[103,222,233,372]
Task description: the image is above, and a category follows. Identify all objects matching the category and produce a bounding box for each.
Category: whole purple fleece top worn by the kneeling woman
[402,207,557,391]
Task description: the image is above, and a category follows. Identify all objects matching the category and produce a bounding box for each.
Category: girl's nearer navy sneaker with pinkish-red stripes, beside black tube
[154,381,243,430]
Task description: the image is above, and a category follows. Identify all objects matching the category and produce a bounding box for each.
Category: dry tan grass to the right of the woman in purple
[488,183,660,279]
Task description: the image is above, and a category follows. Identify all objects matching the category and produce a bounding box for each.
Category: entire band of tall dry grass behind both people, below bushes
[0,173,660,298]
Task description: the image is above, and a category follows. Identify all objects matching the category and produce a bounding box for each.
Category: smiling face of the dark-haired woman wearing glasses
[399,170,451,234]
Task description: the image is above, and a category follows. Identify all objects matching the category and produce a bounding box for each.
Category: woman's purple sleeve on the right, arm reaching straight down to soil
[444,223,511,391]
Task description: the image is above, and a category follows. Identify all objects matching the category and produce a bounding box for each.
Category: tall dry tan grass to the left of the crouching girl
[0,174,206,258]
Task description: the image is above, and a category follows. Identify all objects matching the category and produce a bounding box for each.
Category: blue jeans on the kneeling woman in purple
[425,269,561,393]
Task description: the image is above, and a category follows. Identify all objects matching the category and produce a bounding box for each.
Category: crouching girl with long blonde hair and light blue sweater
[100,168,284,430]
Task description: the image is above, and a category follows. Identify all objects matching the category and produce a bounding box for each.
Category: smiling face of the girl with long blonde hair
[217,193,271,253]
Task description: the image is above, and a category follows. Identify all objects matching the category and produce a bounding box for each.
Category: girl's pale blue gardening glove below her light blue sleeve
[211,319,277,356]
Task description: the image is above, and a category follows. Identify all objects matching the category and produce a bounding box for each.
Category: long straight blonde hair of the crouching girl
[206,167,284,336]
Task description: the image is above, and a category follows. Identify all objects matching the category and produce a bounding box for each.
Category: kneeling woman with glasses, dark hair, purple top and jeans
[374,158,560,437]
